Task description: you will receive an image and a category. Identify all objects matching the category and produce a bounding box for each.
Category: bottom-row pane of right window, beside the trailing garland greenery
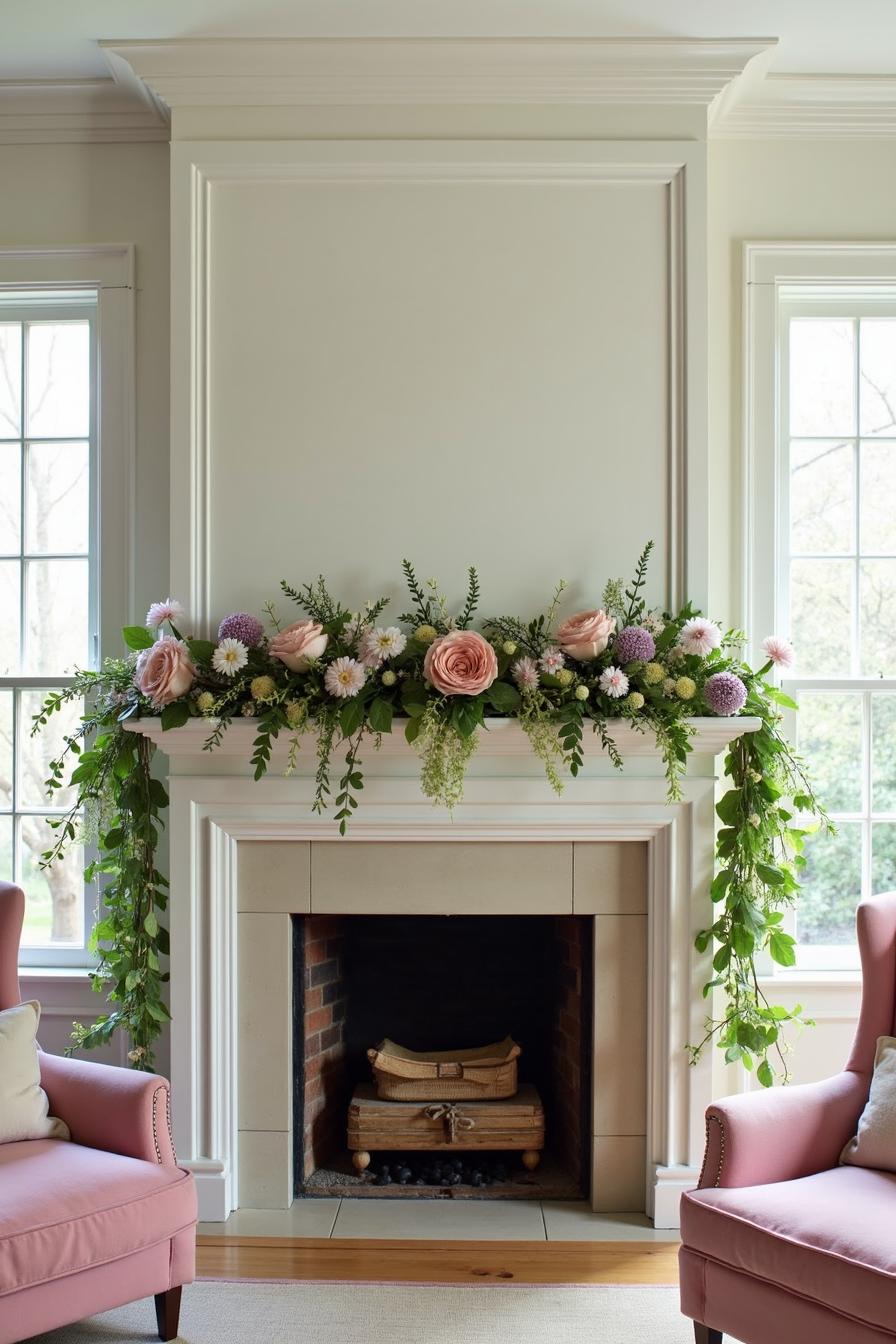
[797,821,862,943]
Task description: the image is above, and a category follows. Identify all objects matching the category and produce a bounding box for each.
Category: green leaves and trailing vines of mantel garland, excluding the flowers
[35,543,832,1085]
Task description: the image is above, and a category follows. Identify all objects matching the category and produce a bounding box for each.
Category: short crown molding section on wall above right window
[711,74,896,140]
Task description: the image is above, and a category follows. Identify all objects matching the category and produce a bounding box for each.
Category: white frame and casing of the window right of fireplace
[742,243,896,985]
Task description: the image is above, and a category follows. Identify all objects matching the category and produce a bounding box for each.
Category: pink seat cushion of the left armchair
[0,1138,196,1298]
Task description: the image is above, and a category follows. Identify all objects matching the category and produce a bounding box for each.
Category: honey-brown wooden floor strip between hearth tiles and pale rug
[196,1236,678,1284]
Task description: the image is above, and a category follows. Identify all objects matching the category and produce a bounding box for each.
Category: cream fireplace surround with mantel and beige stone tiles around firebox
[132,719,756,1227]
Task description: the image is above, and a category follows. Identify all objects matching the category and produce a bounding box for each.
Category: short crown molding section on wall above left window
[0,69,169,145]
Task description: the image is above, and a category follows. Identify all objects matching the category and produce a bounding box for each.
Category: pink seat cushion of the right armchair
[681,1167,896,1329]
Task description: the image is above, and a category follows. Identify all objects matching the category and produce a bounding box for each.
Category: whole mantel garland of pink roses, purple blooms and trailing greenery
[34,543,829,1086]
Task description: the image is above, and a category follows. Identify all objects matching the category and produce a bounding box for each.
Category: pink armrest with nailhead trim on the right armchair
[700,1073,868,1189]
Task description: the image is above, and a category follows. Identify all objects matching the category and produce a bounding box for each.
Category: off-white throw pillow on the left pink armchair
[0,1001,71,1144]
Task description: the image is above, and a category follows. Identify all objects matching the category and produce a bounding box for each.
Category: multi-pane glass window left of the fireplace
[0,292,98,960]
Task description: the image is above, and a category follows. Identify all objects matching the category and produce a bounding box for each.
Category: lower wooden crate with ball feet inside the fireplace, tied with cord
[348,1083,544,1171]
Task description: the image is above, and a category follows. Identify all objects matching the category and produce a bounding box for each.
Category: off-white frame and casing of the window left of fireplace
[0,243,136,976]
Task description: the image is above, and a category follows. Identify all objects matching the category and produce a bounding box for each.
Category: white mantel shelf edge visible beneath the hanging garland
[125,715,762,763]
